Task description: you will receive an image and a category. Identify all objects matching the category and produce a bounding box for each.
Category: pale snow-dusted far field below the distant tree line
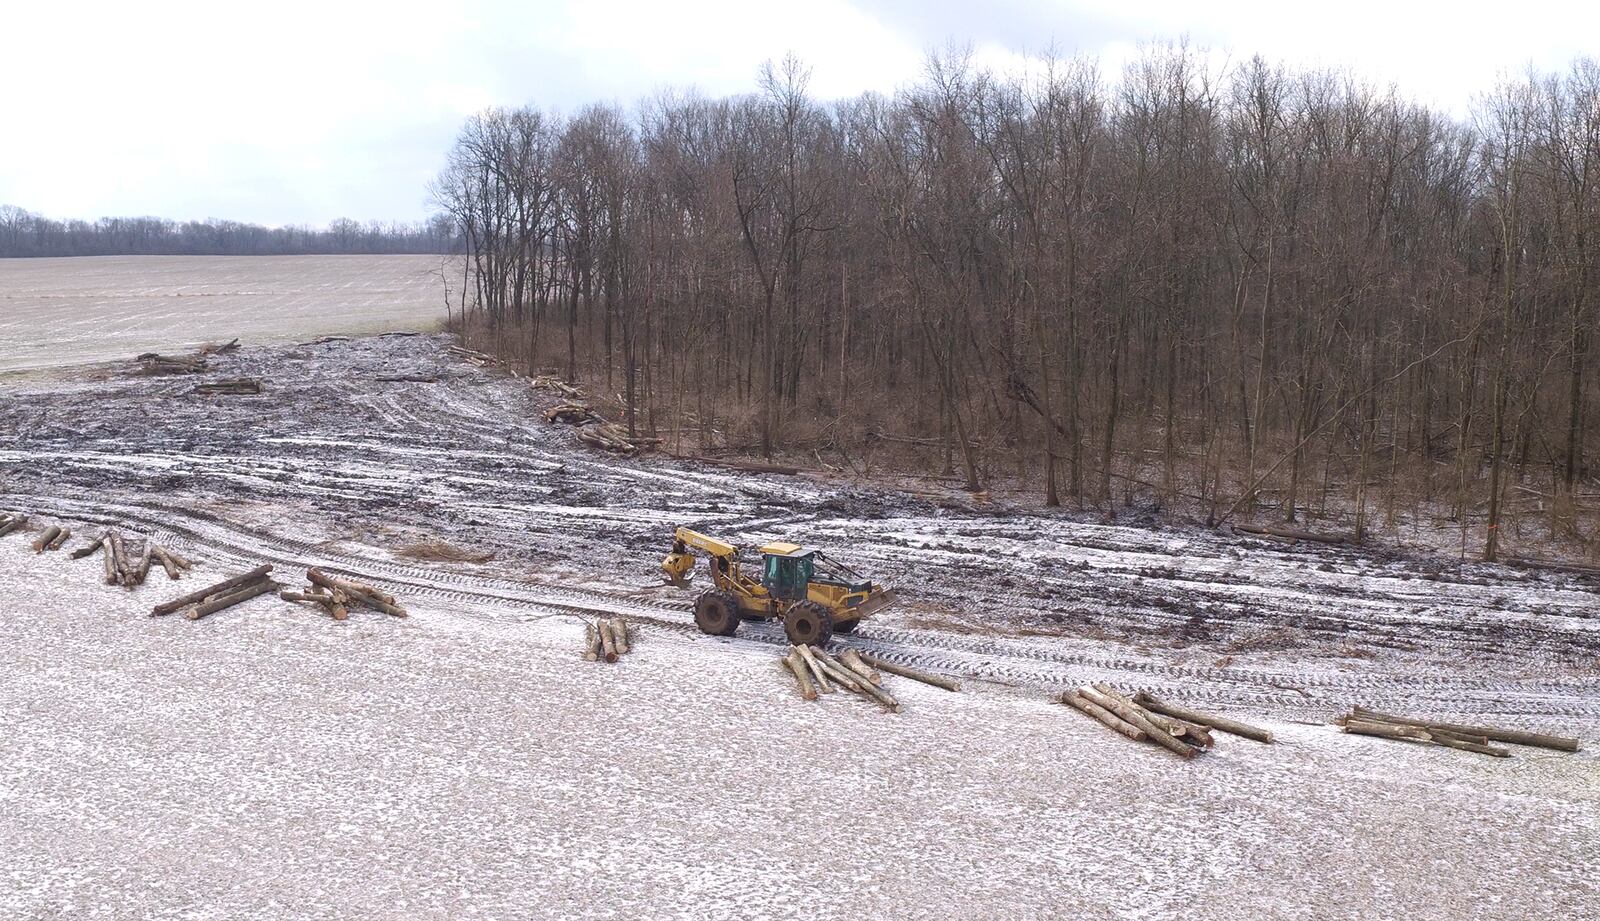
[0,256,445,371]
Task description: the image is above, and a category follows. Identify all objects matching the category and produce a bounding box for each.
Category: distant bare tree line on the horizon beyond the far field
[0,205,456,257]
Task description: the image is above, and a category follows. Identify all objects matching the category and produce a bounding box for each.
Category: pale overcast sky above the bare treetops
[0,0,1600,224]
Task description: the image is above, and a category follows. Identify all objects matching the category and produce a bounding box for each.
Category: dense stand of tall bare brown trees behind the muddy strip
[434,46,1600,558]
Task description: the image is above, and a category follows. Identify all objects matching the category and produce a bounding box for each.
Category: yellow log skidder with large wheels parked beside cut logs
[661,528,894,646]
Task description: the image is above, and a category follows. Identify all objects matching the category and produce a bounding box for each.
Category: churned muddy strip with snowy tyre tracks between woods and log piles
[0,336,1600,716]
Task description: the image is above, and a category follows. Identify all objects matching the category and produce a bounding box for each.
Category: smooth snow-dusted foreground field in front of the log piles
[0,536,1600,919]
